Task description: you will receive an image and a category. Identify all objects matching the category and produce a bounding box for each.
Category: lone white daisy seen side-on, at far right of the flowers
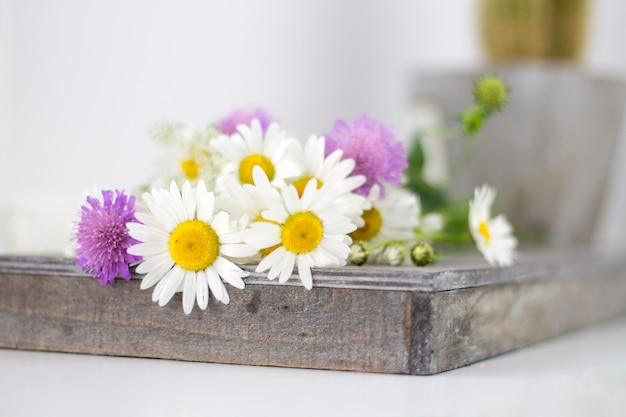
[469,185,517,266]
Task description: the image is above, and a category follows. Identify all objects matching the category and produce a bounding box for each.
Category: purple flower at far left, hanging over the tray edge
[75,190,141,285]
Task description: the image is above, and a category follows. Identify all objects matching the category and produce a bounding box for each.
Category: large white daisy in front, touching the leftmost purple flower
[128,181,253,314]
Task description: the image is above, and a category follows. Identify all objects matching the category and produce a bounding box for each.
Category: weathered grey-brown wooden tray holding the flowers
[0,252,626,375]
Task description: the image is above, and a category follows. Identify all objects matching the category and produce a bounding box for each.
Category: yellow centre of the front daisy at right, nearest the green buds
[280,211,324,254]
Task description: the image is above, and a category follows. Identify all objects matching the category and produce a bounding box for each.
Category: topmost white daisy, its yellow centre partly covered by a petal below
[211,119,299,186]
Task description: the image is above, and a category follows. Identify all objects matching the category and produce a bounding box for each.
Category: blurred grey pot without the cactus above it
[416,63,626,247]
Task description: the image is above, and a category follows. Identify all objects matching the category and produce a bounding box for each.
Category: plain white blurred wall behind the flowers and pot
[0,0,626,251]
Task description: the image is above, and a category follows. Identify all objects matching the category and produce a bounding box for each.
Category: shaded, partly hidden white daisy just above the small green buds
[350,185,421,243]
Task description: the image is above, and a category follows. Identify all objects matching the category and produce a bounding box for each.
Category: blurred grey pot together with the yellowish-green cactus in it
[414,0,626,251]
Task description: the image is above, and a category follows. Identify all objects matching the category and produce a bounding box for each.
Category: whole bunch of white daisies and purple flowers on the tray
[74,111,517,314]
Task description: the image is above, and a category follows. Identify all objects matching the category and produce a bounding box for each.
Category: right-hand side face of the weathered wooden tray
[412,272,626,374]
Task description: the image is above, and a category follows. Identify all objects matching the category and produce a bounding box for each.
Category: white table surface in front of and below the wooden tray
[0,317,626,417]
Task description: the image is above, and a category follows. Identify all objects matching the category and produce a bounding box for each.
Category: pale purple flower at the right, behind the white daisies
[326,115,408,197]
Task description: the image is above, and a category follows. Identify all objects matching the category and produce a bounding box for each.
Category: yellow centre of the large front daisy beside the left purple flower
[170,220,220,272]
